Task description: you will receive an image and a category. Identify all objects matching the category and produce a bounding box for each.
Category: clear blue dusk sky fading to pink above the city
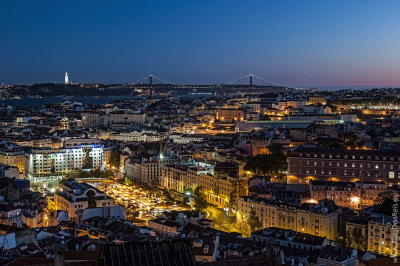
[0,0,400,87]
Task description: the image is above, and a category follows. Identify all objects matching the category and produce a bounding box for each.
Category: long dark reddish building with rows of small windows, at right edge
[288,146,400,185]
